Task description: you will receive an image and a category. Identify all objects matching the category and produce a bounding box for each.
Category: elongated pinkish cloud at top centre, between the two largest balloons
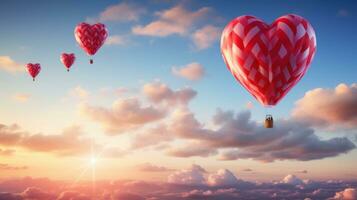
[132,5,211,37]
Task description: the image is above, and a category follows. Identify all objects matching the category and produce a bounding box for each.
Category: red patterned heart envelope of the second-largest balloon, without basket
[74,23,108,55]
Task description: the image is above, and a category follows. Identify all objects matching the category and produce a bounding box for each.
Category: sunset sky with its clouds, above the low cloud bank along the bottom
[0,0,357,197]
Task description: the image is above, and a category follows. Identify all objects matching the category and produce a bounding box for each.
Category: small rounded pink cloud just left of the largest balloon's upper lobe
[191,25,222,50]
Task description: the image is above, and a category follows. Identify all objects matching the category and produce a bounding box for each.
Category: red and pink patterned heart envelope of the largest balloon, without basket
[221,15,316,106]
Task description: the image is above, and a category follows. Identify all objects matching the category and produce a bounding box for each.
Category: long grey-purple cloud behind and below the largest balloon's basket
[161,109,356,162]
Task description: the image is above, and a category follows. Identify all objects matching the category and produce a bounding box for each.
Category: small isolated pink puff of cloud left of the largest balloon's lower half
[172,62,205,81]
